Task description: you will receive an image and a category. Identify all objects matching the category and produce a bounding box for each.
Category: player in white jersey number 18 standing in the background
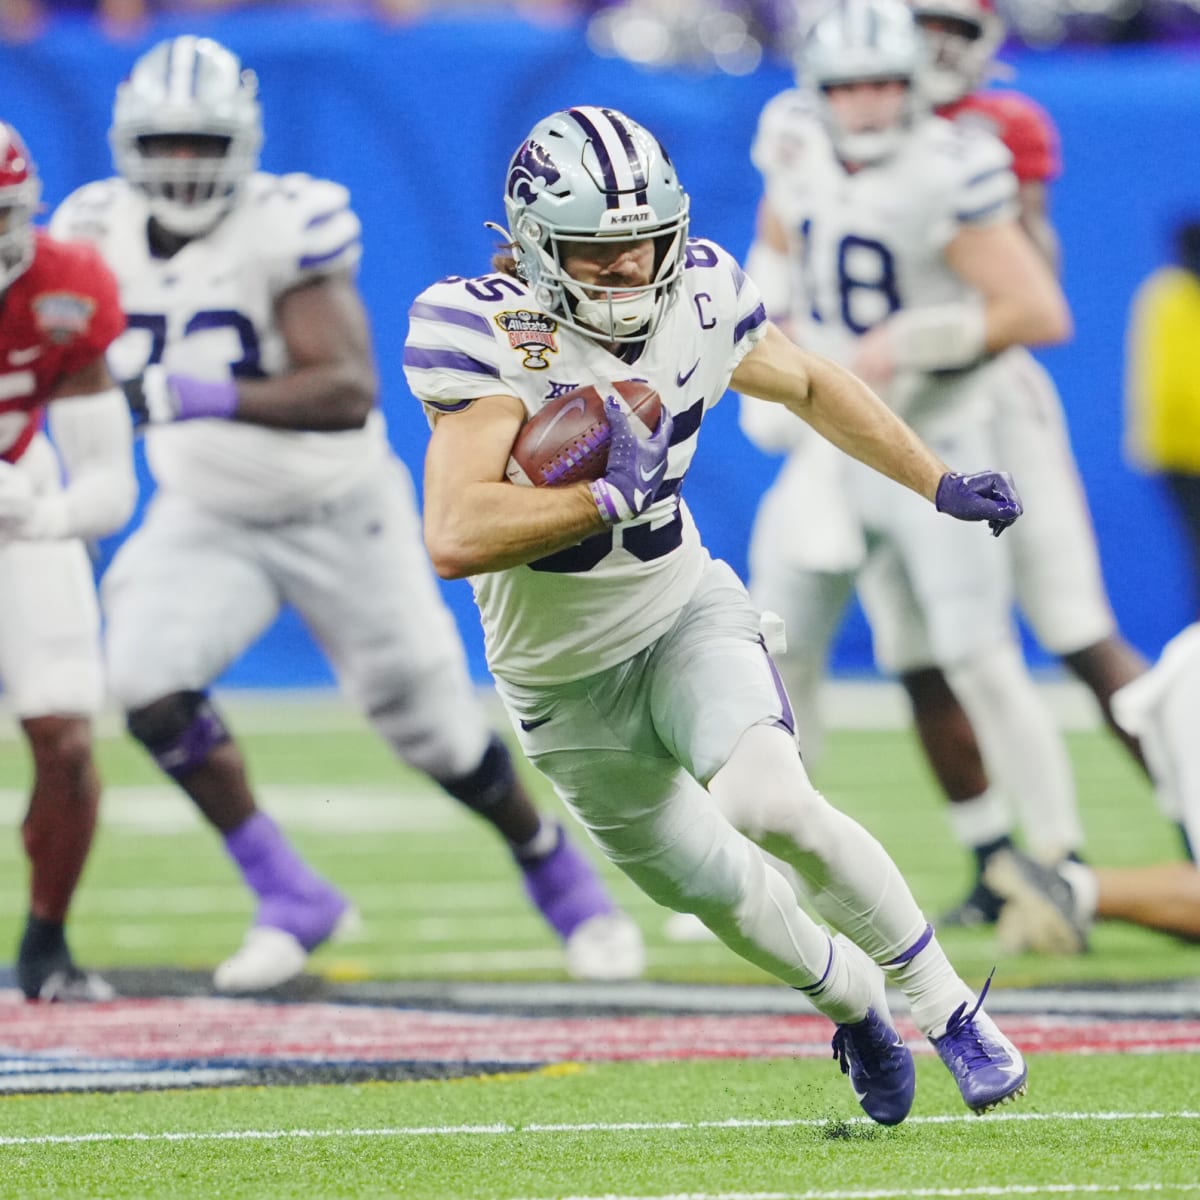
[743,0,1082,926]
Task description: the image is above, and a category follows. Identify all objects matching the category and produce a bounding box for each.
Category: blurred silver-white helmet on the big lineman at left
[108,35,263,236]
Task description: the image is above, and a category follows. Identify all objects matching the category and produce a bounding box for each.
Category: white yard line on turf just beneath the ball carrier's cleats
[0,1110,1200,1147]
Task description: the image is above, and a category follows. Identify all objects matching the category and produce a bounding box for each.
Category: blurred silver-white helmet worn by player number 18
[796,0,929,163]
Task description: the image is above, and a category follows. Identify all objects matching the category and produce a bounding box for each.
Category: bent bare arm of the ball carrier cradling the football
[425,397,605,580]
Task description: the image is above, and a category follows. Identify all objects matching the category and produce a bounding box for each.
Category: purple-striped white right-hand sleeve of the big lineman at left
[247,173,362,296]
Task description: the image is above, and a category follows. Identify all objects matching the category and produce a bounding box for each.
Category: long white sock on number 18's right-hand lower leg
[946,643,1084,862]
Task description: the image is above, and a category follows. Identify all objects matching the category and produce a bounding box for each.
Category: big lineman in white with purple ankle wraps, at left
[54,36,643,991]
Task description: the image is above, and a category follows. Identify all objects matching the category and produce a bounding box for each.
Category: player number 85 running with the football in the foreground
[404,107,1026,1124]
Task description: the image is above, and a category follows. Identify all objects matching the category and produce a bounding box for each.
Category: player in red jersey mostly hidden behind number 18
[897,0,1146,924]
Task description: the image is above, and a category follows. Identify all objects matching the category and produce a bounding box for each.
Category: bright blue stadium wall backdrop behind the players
[0,13,1200,686]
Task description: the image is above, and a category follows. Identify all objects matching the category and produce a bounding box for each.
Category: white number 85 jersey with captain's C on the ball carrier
[404,239,766,684]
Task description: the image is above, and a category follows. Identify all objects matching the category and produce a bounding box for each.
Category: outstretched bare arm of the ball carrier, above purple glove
[732,326,949,500]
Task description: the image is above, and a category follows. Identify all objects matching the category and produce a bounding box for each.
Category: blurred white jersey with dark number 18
[751,90,1018,427]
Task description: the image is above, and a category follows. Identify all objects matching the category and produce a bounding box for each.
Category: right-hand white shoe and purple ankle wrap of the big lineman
[520,827,646,979]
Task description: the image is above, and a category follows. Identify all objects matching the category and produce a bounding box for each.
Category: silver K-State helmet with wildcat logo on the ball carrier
[504,107,688,342]
